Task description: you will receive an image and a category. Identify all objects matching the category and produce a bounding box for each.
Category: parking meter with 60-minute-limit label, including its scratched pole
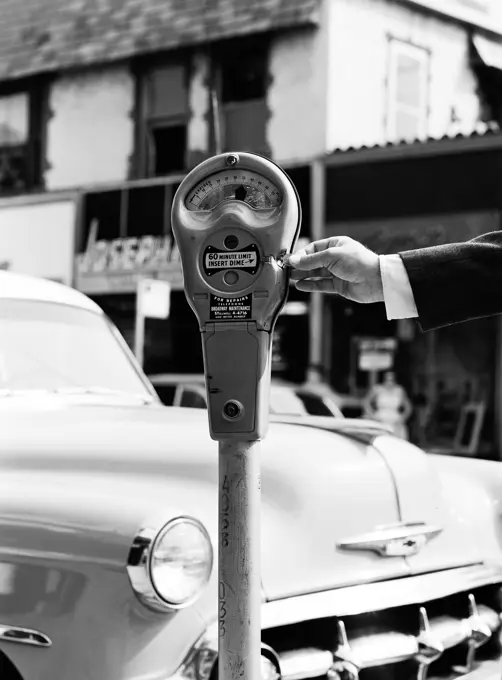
[172,153,301,680]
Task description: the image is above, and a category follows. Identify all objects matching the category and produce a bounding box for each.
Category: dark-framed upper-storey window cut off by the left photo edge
[0,90,41,195]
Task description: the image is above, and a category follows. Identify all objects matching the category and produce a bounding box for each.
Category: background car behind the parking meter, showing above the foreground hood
[149,373,356,418]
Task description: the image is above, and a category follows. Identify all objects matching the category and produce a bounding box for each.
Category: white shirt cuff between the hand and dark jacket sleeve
[380,255,418,321]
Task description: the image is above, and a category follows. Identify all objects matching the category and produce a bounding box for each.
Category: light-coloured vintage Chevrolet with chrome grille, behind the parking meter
[0,272,502,680]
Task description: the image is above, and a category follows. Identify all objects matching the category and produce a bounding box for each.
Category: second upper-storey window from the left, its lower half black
[138,63,189,177]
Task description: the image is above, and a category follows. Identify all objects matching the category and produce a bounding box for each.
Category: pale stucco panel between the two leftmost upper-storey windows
[45,67,134,189]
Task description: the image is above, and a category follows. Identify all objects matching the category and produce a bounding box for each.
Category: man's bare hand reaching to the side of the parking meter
[289,236,384,302]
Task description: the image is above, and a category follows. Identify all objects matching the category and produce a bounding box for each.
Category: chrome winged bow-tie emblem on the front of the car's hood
[336,522,443,557]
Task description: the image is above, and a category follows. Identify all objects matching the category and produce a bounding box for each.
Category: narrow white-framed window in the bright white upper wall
[386,39,430,142]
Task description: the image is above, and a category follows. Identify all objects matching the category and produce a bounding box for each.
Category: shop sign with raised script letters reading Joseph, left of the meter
[76,235,183,294]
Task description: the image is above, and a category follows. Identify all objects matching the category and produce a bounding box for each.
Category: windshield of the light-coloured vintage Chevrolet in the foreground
[0,299,151,400]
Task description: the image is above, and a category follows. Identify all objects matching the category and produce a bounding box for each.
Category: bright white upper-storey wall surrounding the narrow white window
[327,0,479,150]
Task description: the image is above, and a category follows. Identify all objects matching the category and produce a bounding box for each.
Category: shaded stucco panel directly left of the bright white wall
[267,12,331,162]
